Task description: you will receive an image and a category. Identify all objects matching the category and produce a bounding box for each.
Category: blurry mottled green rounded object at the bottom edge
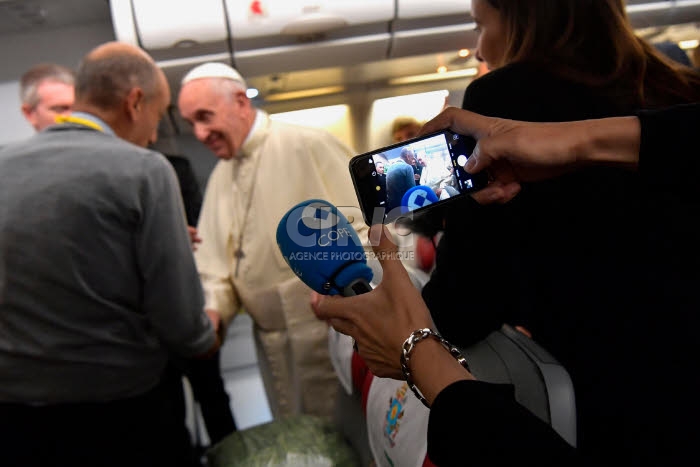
[207,415,360,467]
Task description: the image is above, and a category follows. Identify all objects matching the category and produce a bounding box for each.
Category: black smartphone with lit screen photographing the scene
[350,130,488,225]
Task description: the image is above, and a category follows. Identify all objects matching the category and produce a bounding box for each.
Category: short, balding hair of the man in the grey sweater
[75,53,161,109]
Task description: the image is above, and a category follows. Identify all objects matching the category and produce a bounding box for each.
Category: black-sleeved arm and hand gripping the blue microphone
[312,226,575,466]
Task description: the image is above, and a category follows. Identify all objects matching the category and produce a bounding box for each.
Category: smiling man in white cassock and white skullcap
[178,63,367,417]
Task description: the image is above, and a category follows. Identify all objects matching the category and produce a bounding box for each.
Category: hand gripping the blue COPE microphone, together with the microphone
[277,200,433,379]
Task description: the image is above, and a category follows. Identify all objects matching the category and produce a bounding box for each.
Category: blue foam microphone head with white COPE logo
[277,199,373,297]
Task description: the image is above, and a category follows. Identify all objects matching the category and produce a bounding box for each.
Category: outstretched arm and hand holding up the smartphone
[421,104,700,204]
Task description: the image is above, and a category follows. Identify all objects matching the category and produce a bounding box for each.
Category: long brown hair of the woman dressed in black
[487,0,700,107]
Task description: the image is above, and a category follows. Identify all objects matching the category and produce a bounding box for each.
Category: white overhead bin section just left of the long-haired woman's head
[389,0,477,58]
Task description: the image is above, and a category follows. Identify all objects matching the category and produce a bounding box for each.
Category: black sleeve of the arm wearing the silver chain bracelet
[428,381,582,467]
